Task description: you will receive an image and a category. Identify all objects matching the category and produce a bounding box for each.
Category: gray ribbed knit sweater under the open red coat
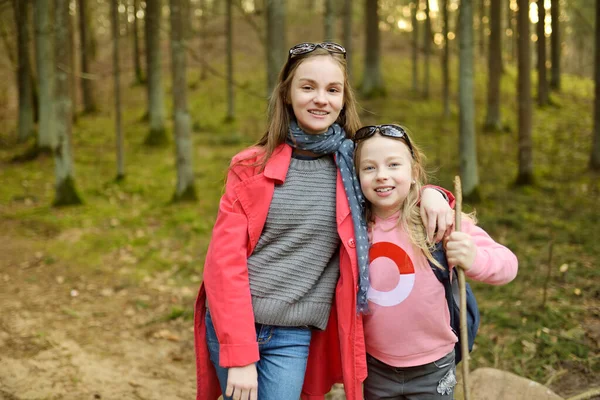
[248,156,340,329]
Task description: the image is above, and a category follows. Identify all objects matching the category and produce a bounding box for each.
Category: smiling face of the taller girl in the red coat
[290,55,344,134]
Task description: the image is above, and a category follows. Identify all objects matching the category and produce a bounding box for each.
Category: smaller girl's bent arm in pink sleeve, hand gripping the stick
[446,219,518,285]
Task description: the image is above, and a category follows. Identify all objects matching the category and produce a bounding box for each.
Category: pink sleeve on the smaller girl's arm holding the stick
[462,218,519,285]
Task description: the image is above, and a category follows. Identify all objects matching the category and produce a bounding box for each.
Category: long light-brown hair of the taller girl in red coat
[256,48,361,167]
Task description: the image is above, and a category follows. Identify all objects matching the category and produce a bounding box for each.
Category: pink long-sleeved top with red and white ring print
[364,214,518,367]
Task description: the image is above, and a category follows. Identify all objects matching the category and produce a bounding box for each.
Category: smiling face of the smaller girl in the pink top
[358,134,413,218]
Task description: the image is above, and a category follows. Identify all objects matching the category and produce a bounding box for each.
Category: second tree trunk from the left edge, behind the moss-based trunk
[34,0,55,151]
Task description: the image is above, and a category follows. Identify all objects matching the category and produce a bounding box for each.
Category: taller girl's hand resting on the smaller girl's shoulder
[421,188,454,243]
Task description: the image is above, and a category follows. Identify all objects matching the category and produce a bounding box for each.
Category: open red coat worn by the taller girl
[194,144,367,400]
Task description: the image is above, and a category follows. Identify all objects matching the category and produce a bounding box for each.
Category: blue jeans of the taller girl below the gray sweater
[206,310,312,400]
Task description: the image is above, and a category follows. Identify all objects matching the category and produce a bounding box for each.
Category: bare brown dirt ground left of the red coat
[0,235,195,400]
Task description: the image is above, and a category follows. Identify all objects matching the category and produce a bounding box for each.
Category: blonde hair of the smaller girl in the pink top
[354,127,443,268]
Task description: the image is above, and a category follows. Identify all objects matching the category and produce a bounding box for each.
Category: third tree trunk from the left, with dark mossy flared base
[53,0,81,206]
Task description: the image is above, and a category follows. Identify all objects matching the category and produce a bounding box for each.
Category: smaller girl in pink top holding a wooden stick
[355,125,517,400]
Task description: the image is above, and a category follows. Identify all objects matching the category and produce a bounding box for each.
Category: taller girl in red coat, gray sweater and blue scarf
[194,43,451,400]
